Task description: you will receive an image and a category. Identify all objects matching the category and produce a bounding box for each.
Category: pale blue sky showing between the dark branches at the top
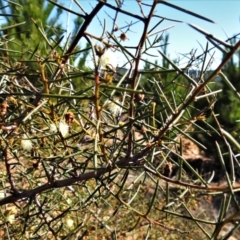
[64,0,240,67]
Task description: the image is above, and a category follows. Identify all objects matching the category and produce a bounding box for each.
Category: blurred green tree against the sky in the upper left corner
[0,0,88,70]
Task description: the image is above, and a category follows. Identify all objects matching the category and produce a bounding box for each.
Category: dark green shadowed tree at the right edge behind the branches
[194,37,240,159]
